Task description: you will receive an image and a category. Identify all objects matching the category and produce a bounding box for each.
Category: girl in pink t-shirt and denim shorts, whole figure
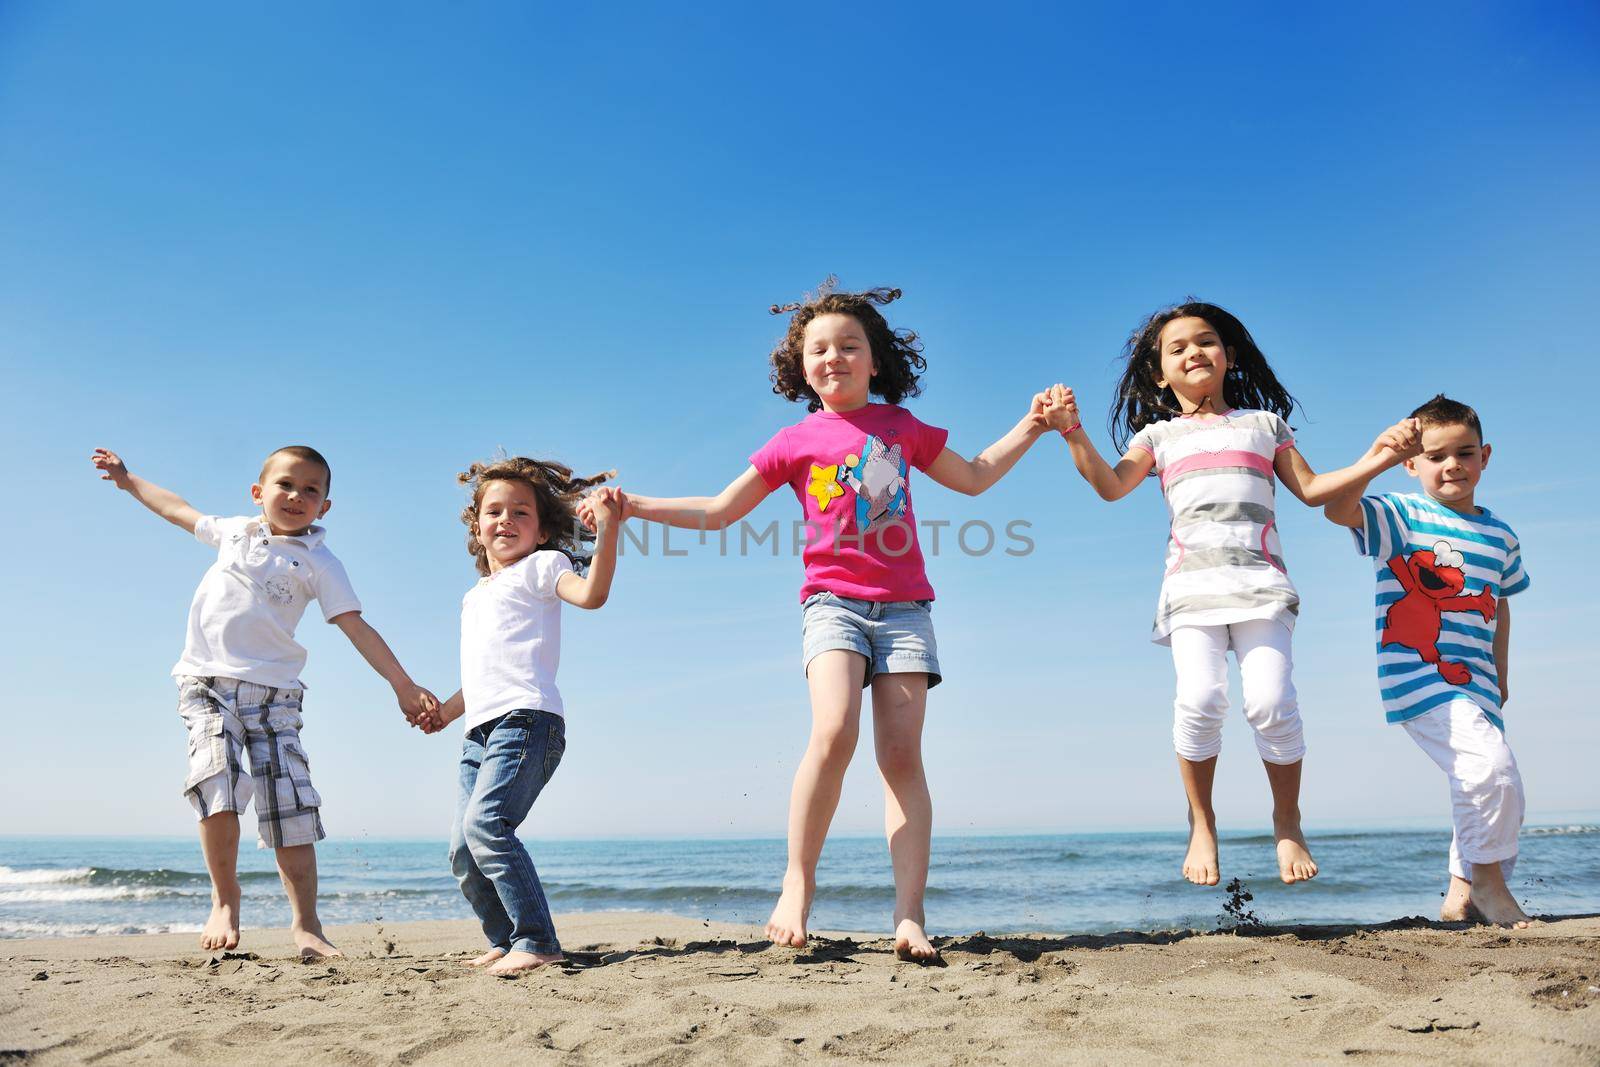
[588,280,1045,960]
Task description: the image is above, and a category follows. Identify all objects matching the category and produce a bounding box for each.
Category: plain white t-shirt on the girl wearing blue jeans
[461,549,573,729]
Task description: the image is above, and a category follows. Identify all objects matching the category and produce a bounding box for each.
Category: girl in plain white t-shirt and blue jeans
[422,456,622,974]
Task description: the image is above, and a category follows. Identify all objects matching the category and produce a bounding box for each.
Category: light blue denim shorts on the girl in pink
[800,590,941,689]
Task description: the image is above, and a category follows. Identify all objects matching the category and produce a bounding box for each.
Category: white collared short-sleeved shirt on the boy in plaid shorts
[173,515,362,688]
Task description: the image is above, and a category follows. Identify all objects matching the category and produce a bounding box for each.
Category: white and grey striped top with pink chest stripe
[1128,408,1299,645]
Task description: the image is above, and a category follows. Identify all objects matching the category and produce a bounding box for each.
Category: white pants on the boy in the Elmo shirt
[1403,701,1523,881]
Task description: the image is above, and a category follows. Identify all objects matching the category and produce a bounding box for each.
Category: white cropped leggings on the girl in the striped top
[1171,619,1306,763]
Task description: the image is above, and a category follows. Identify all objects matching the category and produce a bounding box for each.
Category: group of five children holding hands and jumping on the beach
[93,286,1530,973]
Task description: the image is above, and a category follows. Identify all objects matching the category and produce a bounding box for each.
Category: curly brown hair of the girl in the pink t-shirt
[770,275,928,411]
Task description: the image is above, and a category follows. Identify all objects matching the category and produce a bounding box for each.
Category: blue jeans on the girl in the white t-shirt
[450,710,566,955]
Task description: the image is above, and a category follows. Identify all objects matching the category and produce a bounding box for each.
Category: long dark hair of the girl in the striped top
[1107,301,1299,454]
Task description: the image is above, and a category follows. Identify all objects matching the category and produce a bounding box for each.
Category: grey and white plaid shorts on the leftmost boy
[178,677,326,848]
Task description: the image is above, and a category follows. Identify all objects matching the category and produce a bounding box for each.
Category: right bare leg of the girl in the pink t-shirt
[872,673,939,960]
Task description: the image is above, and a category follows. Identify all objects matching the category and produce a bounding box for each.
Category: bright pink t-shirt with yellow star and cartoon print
[750,403,949,601]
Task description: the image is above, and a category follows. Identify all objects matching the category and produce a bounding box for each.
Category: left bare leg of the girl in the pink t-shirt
[766,649,867,949]
